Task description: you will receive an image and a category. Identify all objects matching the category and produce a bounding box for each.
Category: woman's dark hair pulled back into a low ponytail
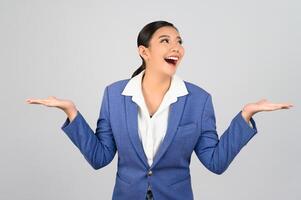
[131,21,178,78]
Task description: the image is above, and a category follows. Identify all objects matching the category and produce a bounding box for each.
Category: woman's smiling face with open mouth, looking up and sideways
[139,26,185,76]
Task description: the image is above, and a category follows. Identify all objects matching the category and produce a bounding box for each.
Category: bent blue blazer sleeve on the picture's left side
[61,86,116,169]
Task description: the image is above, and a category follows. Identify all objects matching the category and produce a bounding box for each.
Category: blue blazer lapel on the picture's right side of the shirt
[151,95,187,168]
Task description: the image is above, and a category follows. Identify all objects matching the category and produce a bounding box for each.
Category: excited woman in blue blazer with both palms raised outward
[27,21,292,200]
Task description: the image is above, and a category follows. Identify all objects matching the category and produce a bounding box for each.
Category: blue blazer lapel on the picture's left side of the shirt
[125,96,149,168]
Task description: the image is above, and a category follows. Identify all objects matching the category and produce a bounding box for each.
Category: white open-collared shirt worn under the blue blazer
[121,70,188,166]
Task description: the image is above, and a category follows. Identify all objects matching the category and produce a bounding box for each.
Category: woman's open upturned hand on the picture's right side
[242,99,293,122]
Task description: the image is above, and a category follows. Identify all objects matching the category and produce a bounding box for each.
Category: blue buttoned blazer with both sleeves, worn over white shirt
[61,79,257,200]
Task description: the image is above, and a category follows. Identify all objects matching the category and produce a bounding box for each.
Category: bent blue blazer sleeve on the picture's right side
[194,94,257,174]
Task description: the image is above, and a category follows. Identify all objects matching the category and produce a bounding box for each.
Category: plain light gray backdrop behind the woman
[0,0,301,200]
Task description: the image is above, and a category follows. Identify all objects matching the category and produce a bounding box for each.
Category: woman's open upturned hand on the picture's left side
[26,96,77,121]
